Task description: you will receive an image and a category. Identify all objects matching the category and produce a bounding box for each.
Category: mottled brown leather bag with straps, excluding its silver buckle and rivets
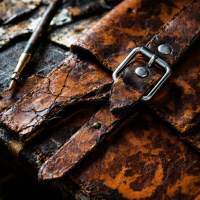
[2,0,200,199]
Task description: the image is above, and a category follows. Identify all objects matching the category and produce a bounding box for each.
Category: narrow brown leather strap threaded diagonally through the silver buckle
[39,1,200,180]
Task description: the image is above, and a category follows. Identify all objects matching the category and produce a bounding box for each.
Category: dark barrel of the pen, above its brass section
[24,0,62,55]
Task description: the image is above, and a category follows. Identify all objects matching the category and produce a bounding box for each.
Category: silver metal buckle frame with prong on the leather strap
[112,47,171,101]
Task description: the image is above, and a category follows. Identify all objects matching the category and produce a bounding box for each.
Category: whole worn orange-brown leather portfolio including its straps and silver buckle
[0,0,200,200]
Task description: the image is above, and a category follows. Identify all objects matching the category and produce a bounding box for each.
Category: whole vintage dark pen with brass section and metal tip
[9,0,62,90]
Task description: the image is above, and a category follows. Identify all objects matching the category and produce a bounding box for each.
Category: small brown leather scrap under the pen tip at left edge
[0,75,43,114]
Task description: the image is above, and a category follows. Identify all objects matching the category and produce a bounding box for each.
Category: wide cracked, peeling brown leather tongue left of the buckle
[1,55,112,141]
